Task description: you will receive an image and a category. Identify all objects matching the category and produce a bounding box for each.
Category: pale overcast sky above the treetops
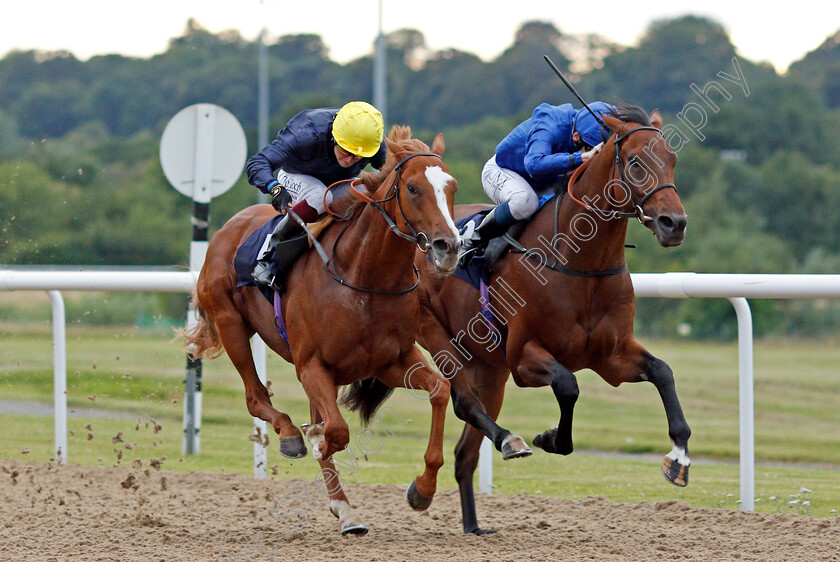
[0,0,840,72]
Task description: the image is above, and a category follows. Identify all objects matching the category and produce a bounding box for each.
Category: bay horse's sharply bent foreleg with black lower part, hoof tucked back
[513,341,580,455]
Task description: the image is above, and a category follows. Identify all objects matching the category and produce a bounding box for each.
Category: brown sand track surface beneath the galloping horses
[0,459,840,562]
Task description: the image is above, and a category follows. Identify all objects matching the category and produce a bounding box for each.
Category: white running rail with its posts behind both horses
[0,269,840,511]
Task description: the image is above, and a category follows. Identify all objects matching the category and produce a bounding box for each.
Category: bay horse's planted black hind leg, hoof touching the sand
[455,358,508,535]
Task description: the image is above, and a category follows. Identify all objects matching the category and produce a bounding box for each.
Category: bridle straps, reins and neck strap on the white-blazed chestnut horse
[325,152,442,295]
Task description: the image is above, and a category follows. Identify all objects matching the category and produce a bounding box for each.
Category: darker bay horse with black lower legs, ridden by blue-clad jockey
[416,106,691,534]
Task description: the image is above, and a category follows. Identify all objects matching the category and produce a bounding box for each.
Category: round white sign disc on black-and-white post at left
[160,103,247,202]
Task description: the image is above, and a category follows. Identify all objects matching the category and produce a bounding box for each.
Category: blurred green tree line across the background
[0,16,840,337]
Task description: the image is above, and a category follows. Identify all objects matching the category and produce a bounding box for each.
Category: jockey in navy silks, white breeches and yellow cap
[245,101,388,290]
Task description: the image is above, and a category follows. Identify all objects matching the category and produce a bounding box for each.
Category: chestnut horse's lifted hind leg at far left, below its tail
[214,304,306,459]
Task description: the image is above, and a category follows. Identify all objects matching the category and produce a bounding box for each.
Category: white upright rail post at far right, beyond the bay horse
[729,297,755,511]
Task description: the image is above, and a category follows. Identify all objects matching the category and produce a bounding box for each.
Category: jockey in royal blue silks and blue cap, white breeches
[461,101,615,265]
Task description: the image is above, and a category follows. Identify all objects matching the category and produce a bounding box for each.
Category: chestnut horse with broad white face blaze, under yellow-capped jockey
[183,126,460,534]
